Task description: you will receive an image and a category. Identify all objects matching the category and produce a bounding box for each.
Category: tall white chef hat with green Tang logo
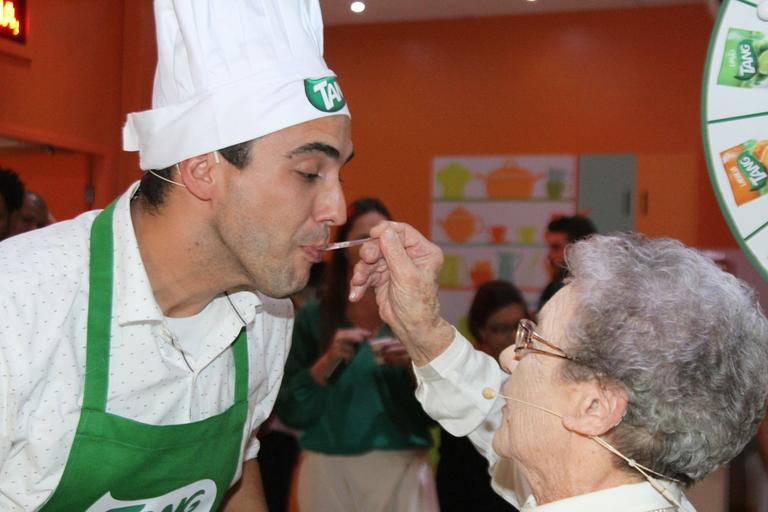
[123,0,349,170]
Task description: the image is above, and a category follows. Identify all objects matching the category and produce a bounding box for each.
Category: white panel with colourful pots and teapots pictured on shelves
[430,155,578,333]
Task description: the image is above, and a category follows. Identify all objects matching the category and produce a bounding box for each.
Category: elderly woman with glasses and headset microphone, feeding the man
[350,229,768,512]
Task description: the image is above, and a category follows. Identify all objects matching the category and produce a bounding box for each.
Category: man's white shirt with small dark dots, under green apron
[0,183,293,512]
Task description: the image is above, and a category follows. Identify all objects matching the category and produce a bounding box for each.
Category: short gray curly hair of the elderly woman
[563,234,768,484]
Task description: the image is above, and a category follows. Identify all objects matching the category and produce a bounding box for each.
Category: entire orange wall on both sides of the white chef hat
[0,0,734,246]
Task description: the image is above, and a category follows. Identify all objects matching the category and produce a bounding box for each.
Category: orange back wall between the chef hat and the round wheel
[325,5,735,246]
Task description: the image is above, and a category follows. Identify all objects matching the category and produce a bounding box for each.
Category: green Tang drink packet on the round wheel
[717,28,768,88]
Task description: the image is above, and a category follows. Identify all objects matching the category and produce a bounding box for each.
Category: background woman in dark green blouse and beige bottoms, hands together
[277,198,437,512]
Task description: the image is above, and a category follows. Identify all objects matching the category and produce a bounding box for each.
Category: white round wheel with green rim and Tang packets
[701,0,768,280]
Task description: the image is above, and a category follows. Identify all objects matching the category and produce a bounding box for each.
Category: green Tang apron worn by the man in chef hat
[41,203,248,512]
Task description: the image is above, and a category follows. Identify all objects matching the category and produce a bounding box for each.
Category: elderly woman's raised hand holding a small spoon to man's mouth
[349,221,453,366]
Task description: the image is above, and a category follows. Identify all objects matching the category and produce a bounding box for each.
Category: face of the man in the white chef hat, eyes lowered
[213,116,352,297]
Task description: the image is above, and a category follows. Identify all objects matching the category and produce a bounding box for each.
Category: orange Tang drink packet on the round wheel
[720,139,768,205]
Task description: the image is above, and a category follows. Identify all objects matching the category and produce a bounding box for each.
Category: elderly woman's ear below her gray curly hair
[563,378,627,436]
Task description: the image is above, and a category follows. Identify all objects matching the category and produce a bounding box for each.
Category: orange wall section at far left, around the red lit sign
[0,0,123,211]
